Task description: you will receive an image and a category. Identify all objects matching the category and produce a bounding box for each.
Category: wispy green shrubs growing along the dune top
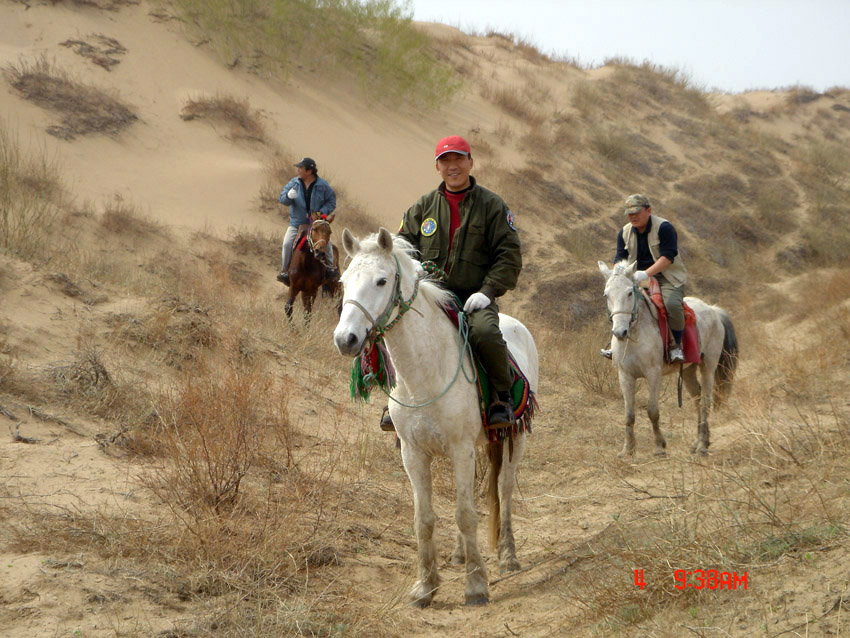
[163,0,457,106]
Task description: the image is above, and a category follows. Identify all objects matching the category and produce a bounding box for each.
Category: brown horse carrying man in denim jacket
[284,219,341,321]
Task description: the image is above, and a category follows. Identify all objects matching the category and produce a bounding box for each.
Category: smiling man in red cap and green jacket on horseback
[381,135,522,430]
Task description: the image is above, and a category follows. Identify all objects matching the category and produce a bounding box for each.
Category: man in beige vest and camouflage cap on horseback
[599,194,688,363]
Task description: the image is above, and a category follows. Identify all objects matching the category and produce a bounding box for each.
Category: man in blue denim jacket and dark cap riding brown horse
[277,157,339,286]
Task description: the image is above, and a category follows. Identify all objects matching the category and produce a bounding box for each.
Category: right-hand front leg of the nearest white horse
[452,444,490,605]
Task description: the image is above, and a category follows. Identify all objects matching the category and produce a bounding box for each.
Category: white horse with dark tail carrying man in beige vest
[599,261,738,456]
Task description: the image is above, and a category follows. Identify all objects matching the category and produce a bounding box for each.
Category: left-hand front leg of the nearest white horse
[401,441,440,607]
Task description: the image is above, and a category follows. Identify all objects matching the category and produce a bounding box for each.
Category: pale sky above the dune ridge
[409,0,850,93]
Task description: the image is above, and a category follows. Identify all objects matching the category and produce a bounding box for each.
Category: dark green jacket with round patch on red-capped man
[398,177,522,300]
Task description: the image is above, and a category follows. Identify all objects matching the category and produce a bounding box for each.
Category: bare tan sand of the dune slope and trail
[0,2,847,638]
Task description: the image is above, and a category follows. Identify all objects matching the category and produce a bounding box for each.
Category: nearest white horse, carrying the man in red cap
[334,228,538,607]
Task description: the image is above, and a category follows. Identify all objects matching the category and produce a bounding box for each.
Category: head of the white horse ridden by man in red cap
[334,228,417,356]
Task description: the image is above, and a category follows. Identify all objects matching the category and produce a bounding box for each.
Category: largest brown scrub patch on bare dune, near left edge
[6,56,138,140]
